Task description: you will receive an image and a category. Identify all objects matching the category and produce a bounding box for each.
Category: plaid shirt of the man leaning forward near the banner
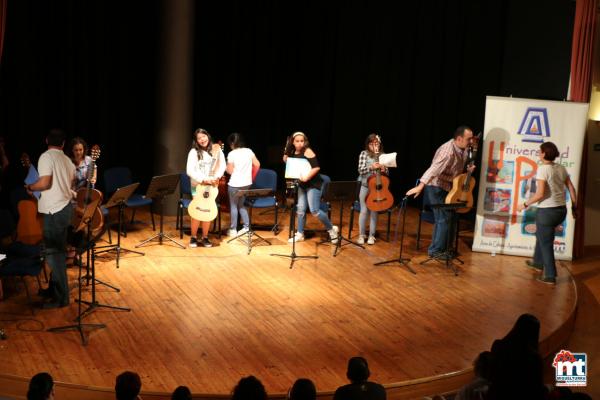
[420,139,467,191]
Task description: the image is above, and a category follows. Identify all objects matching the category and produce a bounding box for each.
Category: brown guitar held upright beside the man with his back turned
[71,144,104,237]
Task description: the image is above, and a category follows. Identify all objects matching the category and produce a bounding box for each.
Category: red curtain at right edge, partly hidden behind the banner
[570,0,598,257]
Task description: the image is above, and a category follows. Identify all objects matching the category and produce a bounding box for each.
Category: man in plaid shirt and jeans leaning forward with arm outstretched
[406,125,475,257]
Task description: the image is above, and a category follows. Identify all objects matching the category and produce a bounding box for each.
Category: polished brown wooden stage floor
[0,209,577,394]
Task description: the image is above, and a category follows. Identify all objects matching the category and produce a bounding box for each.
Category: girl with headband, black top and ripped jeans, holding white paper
[283,132,339,244]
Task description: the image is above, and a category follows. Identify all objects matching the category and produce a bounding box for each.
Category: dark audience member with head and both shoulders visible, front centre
[333,357,386,400]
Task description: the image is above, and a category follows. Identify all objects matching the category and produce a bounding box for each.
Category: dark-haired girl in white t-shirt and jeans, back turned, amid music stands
[227,133,260,237]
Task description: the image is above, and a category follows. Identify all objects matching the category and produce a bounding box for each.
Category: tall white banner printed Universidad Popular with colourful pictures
[473,96,588,260]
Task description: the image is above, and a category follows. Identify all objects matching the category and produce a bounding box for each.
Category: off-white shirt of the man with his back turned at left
[38,149,75,214]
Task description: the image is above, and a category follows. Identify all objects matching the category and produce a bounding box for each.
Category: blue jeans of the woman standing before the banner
[533,206,567,278]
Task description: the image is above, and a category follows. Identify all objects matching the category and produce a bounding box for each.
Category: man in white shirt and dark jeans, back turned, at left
[25,129,75,308]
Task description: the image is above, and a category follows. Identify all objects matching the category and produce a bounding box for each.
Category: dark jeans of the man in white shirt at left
[43,203,73,304]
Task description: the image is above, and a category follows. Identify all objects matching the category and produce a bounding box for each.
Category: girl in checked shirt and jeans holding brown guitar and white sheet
[356,133,388,244]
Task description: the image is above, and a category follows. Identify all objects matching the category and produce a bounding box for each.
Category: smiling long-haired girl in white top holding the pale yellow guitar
[186,129,226,248]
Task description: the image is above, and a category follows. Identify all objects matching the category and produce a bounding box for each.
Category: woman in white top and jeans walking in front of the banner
[518,142,577,284]
